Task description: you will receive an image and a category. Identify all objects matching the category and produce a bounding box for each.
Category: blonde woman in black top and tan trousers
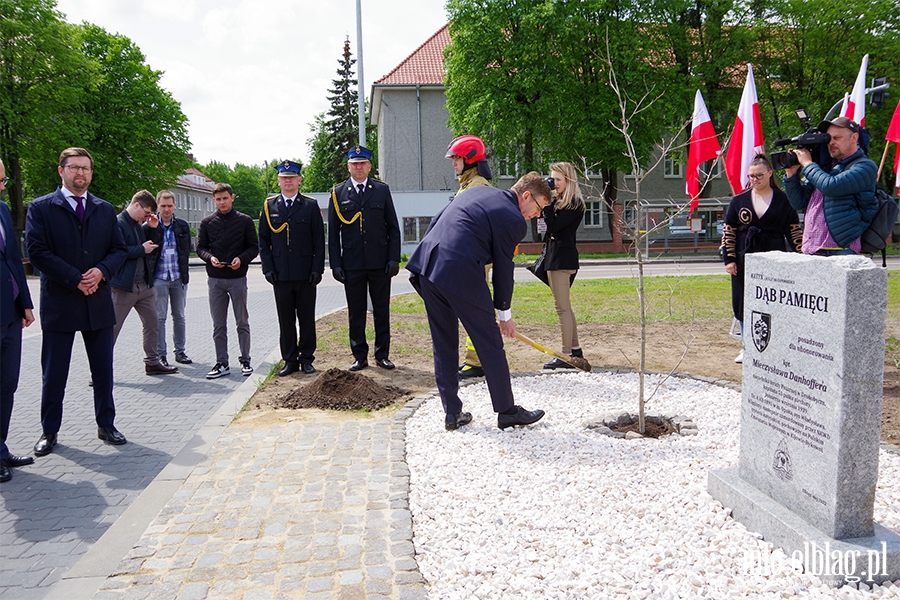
[542,162,585,369]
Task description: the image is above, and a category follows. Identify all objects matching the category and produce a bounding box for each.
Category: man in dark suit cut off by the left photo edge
[0,161,34,481]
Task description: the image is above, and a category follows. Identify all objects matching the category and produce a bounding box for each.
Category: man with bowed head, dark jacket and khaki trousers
[109,190,178,375]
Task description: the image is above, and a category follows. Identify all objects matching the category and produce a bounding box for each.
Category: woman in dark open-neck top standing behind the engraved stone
[721,154,803,363]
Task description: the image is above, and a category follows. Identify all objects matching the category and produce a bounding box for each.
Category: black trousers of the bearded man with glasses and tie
[41,327,116,434]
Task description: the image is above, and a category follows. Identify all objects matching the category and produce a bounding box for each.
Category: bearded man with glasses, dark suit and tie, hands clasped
[25,148,126,456]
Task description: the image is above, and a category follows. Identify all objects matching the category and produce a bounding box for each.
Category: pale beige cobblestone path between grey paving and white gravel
[94,396,426,600]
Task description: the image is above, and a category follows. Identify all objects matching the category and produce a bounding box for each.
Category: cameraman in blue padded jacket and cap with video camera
[784,117,878,256]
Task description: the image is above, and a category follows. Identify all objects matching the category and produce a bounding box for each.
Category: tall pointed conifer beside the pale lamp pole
[301,40,378,192]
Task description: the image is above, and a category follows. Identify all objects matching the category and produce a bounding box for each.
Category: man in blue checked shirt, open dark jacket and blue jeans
[153,190,194,366]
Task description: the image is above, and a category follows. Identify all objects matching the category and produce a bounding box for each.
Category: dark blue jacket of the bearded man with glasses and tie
[25,188,125,331]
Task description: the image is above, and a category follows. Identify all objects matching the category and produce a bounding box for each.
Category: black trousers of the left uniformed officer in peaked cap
[274,281,316,363]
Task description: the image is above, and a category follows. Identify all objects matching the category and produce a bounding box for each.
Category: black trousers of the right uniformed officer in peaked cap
[344,269,391,360]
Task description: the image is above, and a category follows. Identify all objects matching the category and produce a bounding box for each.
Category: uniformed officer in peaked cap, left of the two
[259,160,325,377]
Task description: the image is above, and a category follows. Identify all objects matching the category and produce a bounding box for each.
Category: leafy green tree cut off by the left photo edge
[0,0,92,232]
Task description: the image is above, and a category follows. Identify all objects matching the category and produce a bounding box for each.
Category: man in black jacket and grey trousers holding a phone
[197,183,259,379]
